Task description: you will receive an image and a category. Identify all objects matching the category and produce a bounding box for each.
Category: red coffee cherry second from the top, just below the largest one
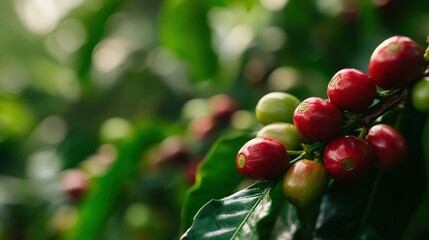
[327,68,377,112]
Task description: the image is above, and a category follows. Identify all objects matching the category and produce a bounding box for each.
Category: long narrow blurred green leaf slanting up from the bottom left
[65,125,163,239]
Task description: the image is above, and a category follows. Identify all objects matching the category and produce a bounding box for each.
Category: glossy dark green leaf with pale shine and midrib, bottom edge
[181,181,275,240]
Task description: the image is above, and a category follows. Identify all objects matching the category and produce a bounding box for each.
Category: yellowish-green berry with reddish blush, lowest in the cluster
[282,159,328,208]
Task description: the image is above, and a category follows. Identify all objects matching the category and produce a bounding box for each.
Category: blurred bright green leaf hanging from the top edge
[160,0,218,82]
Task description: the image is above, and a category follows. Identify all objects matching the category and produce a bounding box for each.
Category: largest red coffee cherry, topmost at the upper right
[368,36,426,89]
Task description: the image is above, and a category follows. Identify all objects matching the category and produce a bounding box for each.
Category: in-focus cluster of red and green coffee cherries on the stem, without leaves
[236,36,427,208]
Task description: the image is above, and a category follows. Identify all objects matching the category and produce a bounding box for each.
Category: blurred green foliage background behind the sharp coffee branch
[0,0,429,239]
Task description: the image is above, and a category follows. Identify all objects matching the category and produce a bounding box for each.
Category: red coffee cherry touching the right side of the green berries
[293,97,343,142]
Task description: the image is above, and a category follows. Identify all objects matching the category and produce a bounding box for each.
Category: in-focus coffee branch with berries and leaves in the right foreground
[181,36,429,239]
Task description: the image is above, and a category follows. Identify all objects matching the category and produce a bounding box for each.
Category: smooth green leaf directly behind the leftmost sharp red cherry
[182,136,252,231]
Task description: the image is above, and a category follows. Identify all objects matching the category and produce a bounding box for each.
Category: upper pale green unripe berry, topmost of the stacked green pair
[255,92,300,125]
